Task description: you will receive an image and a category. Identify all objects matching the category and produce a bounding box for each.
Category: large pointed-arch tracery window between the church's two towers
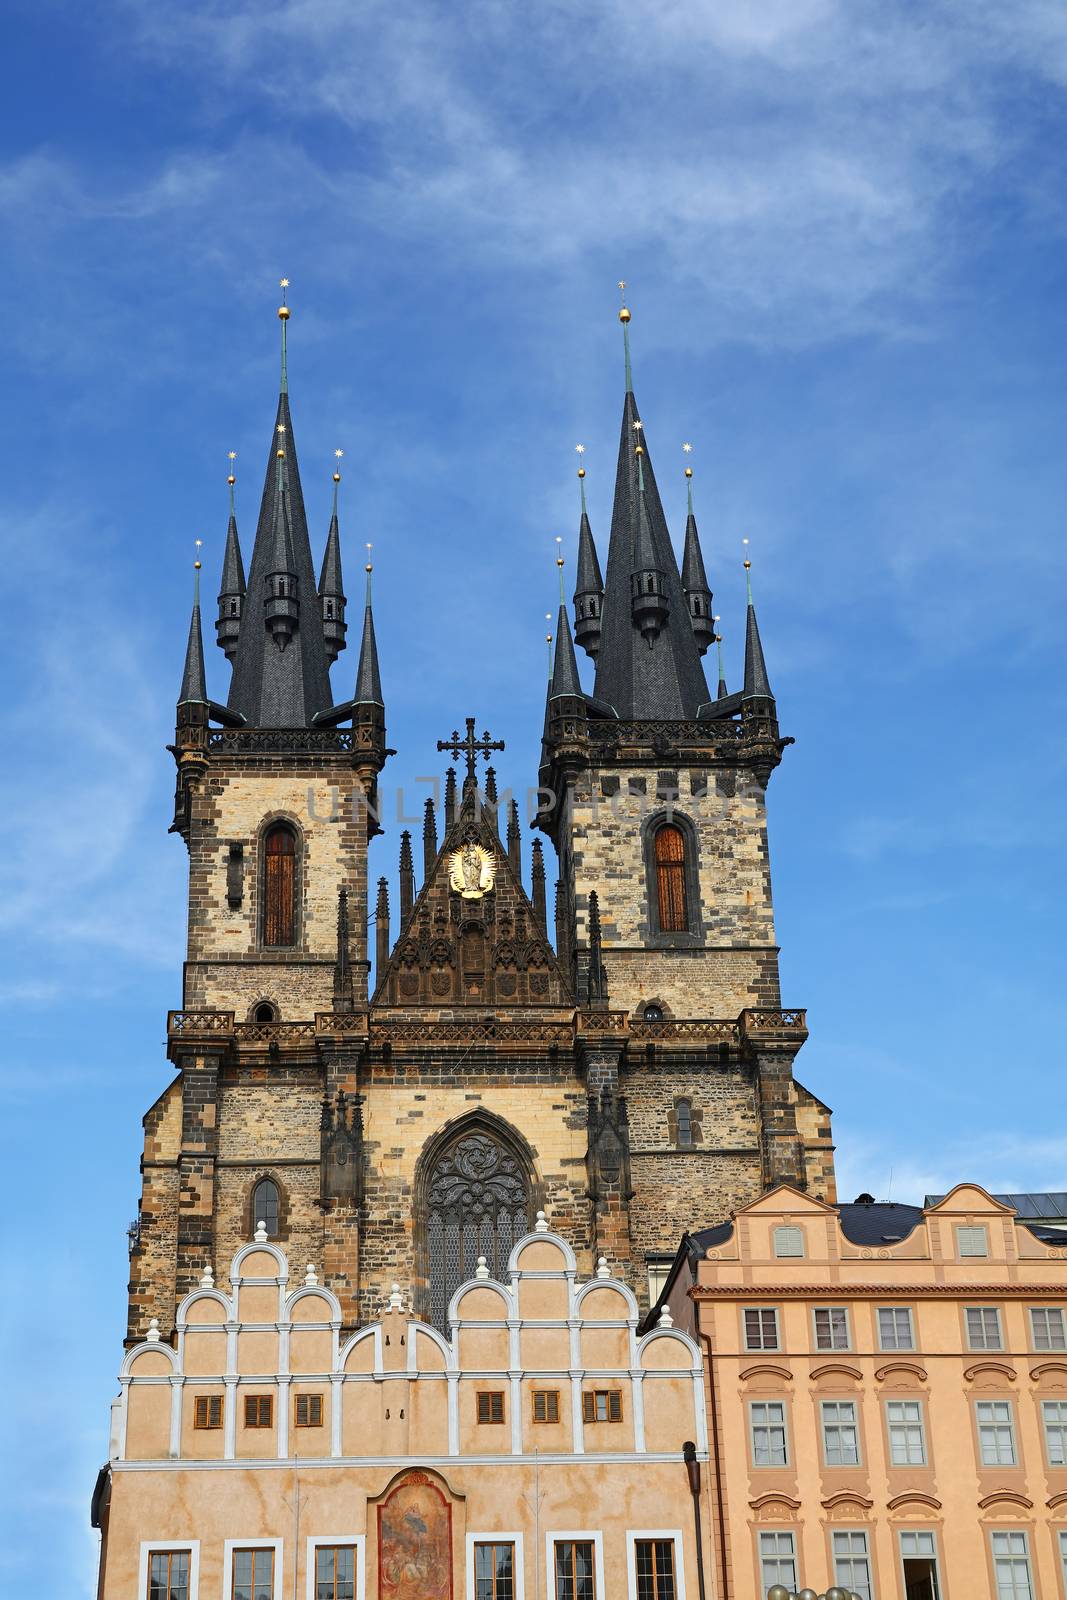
[426,1130,530,1333]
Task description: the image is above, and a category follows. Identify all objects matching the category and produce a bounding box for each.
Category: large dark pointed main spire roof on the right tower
[593,392,710,720]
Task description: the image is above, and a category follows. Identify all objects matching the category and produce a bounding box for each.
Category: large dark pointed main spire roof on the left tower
[227,394,333,728]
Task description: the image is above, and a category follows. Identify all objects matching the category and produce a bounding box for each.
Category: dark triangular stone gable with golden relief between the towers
[374,794,574,1010]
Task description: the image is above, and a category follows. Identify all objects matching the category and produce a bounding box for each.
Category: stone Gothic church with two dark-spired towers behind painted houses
[128,291,833,1344]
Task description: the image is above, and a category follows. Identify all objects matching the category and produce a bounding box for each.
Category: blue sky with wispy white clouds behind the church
[0,0,1067,1600]
